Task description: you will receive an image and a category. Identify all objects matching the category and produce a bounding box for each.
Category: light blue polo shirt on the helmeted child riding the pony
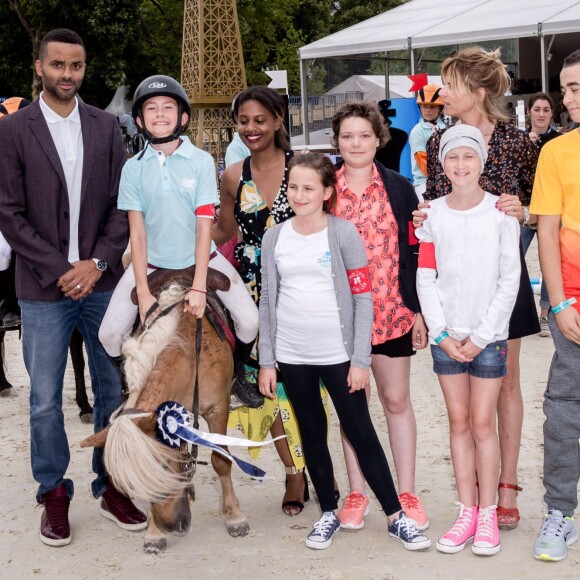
[117,137,219,269]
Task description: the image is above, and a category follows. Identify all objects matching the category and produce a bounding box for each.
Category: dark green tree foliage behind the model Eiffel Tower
[0,0,414,107]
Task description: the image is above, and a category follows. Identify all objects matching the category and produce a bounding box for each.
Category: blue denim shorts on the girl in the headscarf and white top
[431,340,507,379]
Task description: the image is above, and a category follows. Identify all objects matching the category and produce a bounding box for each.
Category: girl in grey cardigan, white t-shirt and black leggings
[259,153,431,550]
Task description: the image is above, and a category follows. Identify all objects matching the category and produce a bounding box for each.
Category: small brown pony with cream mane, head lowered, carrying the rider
[81,285,250,553]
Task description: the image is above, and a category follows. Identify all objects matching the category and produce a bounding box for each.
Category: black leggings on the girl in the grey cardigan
[279,361,401,516]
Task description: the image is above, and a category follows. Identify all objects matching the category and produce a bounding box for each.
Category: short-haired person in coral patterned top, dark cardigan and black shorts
[332,101,429,530]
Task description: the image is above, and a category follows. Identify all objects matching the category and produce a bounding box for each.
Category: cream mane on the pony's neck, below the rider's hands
[122,284,187,395]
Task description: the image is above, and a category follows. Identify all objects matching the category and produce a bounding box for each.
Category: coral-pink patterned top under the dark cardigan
[334,165,415,345]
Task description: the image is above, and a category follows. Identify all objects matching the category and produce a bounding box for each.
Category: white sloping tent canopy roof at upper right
[299,0,580,60]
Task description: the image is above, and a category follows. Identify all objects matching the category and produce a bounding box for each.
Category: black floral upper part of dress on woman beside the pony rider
[234,151,294,304]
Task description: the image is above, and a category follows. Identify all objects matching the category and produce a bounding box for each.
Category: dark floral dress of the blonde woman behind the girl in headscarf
[424,121,540,339]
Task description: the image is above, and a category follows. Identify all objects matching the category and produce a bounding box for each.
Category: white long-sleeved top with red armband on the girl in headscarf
[416,192,521,348]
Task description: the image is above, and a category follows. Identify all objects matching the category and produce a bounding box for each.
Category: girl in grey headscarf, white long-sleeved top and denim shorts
[417,124,520,555]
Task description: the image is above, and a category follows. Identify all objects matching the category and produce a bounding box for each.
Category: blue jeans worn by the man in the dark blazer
[20,291,121,501]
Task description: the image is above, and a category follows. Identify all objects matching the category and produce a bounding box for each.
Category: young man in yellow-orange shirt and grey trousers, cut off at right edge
[530,50,580,562]
